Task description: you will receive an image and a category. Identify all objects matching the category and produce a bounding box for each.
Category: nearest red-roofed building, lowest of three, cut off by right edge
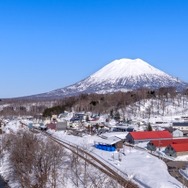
[165,143,188,157]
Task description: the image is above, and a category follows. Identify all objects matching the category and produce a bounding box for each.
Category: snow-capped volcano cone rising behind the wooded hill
[32,58,187,97]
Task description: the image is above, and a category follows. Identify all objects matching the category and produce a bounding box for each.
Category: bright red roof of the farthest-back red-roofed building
[129,131,172,140]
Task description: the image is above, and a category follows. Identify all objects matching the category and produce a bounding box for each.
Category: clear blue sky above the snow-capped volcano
[0,0,188,98]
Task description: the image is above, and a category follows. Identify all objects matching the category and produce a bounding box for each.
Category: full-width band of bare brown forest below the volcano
[0,87,188,117]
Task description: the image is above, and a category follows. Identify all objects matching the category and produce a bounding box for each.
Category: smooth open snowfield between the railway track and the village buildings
[49,131,182,188]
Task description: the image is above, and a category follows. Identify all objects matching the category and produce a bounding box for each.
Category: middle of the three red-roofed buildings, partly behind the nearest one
[147,138,188,151]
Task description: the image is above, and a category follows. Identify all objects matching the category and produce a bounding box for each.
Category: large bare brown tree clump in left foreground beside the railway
[4,132,66,188]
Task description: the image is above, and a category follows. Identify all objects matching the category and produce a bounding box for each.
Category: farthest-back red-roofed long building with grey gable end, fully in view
[126,131,172,144]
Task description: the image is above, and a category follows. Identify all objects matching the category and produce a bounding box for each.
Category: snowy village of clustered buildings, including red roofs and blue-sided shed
[17,112,188,158]
